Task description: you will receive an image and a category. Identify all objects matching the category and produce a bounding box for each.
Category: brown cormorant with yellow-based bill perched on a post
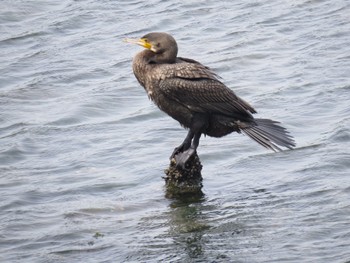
[124,32,296,169]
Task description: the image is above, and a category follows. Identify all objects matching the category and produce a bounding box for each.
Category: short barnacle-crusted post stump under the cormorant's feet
[164,153,203,198]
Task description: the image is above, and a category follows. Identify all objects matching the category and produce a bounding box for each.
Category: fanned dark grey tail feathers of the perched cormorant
[237,119,295,152]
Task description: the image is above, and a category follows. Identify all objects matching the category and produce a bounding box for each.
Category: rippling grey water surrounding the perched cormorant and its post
[0,0,350,262]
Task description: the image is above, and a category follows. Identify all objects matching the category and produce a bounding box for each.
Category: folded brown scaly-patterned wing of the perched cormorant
[159,62,256,119]
